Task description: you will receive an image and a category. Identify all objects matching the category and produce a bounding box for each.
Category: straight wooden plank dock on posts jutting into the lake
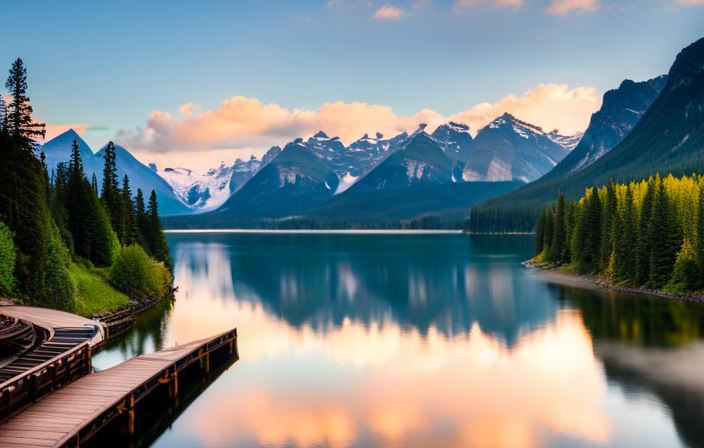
[0,329,237,448]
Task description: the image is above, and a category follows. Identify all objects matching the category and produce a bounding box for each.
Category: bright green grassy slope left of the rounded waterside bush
[71,263,130,316]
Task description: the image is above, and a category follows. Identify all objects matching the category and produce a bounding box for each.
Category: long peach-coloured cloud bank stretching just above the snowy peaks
[116,84,601,165]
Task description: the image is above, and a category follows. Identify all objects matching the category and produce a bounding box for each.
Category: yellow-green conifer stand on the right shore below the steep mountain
[535,175,704,292]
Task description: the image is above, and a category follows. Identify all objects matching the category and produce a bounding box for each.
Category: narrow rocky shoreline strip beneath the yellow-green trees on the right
[521,259,704,303]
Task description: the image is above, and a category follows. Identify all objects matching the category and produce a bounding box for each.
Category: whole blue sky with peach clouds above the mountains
[0,0,704,171]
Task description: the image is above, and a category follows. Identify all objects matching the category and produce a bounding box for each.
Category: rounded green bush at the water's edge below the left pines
[109,244,171,300]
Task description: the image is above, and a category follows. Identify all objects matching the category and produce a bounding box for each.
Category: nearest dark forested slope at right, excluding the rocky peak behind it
[470,39,704,232]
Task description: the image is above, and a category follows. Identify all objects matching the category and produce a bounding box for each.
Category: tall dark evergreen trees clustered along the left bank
[0,59,173,310]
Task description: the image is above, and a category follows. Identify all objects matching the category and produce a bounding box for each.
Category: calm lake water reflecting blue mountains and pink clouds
[94,234,704,448]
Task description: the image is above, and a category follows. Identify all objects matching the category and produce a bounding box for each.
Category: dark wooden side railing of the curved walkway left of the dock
[0,341,91,423]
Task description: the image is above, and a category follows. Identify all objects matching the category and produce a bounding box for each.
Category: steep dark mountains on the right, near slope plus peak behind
[470,39,704,232]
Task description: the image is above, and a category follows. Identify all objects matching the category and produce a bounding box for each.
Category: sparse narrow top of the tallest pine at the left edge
[5,58,46,152]
